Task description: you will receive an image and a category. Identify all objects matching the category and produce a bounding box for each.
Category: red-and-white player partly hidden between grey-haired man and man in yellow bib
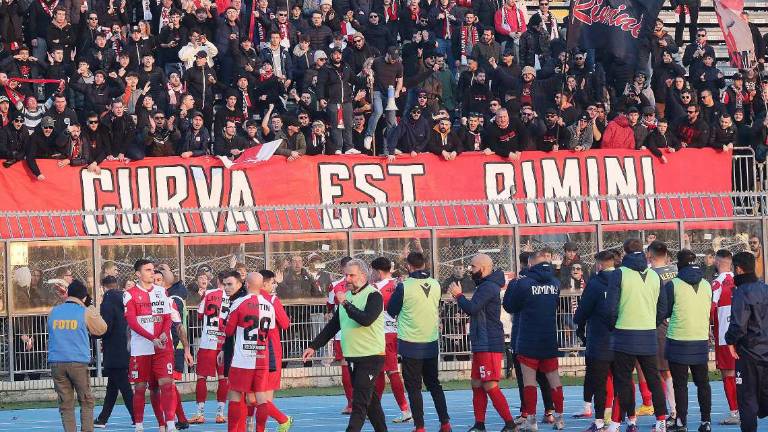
[371,257,413,423]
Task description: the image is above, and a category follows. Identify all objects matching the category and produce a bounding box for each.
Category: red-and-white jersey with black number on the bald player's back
[226,294,275,369]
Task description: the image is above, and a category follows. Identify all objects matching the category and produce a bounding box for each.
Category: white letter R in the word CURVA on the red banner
[155,166,189,234]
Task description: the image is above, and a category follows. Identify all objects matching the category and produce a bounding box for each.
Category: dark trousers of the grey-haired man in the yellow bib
[347,356,387,432]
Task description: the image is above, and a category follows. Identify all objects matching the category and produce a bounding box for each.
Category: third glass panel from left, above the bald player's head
[184,235,265,306]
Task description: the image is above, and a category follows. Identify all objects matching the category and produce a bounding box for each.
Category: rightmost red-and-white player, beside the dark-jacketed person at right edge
[712,249,739,425]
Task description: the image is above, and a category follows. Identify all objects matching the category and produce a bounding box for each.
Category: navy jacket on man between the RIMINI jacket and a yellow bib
[573,268,616,361]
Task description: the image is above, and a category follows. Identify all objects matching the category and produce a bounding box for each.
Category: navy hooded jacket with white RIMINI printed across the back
[504,262,560,359]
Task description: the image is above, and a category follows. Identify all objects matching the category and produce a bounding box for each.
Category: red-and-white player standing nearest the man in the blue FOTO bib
[123,259,179,432]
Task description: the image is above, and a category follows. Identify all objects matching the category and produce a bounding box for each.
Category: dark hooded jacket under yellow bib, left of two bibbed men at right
[606,252,664,355]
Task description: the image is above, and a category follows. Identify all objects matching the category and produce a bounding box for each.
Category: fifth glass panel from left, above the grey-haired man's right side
[352,231,432,277]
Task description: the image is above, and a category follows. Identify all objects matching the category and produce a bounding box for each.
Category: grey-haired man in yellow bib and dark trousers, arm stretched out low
[302,259,387,432]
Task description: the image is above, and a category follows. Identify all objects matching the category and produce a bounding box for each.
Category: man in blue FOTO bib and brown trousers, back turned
[47,280,107,432]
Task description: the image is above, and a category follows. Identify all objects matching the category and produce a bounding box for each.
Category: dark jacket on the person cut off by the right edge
[725,273,768,365]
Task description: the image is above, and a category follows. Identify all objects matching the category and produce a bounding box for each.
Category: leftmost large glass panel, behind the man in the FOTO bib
[8,240,93,314]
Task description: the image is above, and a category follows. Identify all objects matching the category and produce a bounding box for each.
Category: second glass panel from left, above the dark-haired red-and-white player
[99,237,179,294]
